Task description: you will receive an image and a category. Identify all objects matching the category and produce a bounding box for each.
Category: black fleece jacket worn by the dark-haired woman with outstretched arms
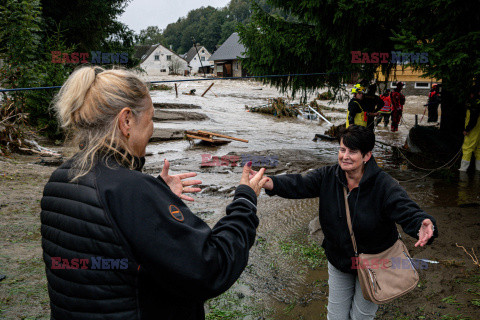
[267,157,438,274]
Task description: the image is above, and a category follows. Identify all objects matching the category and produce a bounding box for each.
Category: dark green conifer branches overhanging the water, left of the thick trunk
[239,0,395,99]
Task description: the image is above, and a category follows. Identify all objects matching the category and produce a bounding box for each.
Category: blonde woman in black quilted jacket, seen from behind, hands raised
[41,67,267,320]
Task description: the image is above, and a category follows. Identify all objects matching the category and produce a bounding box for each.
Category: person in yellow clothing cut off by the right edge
[459,86,480,171]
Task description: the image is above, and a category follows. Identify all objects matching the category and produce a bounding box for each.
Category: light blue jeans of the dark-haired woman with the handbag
[327,262,378,320]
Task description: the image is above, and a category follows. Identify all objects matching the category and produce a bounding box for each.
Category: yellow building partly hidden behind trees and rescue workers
[376,65,442,95]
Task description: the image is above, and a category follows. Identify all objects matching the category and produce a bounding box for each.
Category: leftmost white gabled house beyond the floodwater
[134,44,189,76]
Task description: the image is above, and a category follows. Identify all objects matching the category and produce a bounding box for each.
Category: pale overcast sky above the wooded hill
[119,0,230,33]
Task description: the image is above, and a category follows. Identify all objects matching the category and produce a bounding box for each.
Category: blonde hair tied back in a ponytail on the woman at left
[53,66,149,180]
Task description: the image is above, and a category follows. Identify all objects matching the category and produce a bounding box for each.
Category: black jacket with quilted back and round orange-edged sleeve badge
[41,154,258,320]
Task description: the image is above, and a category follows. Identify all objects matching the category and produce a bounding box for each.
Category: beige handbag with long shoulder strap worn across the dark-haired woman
[343,188,419,304]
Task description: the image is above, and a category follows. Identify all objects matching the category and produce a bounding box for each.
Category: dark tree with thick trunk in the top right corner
[393,0,480,140]
